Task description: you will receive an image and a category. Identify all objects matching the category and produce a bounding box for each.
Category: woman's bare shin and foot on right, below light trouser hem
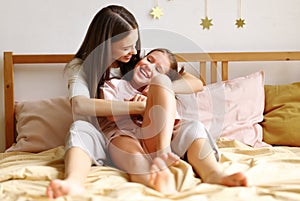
[187,138,247,186]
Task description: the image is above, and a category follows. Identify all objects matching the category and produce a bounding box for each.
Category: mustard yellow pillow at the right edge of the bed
[261,82,300,146]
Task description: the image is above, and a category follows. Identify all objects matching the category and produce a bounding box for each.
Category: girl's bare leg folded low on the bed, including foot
[109,135,179,194]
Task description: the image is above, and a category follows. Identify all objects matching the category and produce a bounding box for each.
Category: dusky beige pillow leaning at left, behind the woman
[7,97,73,152]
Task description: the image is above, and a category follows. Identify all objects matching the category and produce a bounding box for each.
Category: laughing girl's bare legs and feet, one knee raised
[109,75,179,194]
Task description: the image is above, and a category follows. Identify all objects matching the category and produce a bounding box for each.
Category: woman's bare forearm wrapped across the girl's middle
[71,96,146,117]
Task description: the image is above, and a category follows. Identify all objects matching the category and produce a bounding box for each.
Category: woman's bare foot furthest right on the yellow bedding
[206,172,247,187]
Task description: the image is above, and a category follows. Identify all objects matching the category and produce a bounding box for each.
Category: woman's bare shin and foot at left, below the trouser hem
[46,147,91,198]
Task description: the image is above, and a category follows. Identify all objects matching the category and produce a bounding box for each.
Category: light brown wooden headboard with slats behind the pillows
[3,52,300,148]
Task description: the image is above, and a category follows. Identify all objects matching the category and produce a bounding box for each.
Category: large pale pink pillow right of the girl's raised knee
[177,71,269,147]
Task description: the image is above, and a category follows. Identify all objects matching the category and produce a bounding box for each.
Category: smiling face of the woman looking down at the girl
[112,29,139,63]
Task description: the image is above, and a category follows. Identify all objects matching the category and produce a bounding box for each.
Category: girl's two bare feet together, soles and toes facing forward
[149,153,179,194]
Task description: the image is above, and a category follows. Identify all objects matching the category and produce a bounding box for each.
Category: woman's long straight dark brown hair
[75,5,141,98]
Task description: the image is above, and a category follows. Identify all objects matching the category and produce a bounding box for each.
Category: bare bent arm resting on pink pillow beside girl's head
[172,72,203,94]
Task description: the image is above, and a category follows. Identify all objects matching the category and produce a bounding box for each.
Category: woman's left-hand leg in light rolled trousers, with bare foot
[46,120,106,198]
